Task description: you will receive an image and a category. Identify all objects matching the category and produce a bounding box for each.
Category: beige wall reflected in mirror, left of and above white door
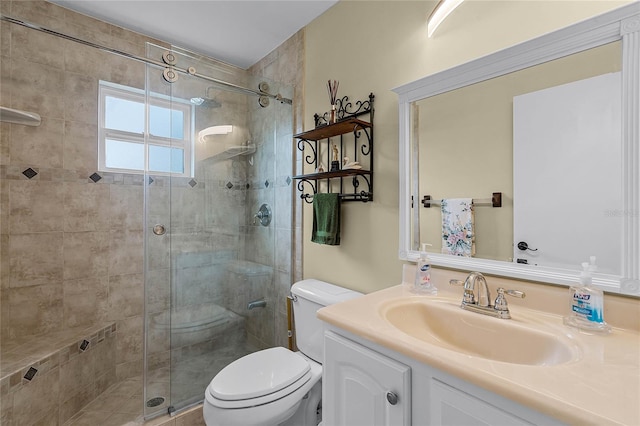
[412,42,621,268]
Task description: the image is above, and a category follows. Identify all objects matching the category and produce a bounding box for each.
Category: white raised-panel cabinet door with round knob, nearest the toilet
[322,332,411,426]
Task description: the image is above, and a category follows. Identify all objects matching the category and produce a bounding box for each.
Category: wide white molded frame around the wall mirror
[393,2,640,295]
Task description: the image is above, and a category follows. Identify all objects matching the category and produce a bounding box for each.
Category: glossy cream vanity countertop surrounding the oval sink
[318,285,640,426]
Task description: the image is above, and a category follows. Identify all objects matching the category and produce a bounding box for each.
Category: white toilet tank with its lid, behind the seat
[291,279,362,364]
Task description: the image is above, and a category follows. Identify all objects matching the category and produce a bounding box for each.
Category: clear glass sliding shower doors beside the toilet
[144,44,293,417]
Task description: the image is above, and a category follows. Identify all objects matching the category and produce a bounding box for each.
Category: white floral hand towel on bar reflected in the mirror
[442,198,476,257]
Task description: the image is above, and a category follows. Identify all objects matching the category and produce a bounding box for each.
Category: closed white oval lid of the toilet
[209,347,311,401]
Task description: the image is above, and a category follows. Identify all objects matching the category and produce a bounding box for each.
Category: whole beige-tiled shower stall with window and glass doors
[0,8,295,424]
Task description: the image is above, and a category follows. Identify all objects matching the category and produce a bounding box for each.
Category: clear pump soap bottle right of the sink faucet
[563,256,611,334]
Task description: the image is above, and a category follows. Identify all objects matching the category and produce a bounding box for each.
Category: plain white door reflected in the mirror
[513,72,623,275]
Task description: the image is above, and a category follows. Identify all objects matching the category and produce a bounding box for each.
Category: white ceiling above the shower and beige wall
[49,0,338,69]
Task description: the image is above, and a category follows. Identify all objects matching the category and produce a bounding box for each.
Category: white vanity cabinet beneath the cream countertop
[322,325,563,426]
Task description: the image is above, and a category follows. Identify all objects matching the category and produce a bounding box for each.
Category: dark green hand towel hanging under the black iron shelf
[311,194,340,246]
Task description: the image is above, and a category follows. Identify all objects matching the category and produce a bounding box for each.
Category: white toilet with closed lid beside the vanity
[203,279,361,426]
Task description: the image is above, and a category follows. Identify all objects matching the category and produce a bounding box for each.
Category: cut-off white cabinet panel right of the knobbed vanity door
[429,379,533,426]
